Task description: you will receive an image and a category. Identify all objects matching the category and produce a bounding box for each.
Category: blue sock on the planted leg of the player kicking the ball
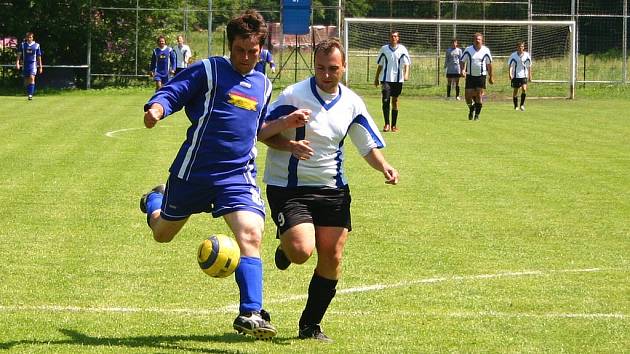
[235,256,262,313]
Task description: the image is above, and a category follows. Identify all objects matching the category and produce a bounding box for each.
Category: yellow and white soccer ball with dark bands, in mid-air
[197,235,241,278]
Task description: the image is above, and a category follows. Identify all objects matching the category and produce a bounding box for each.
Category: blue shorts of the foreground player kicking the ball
[160,175,265,221]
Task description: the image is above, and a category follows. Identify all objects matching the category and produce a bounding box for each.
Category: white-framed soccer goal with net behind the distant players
[344,18,576,98]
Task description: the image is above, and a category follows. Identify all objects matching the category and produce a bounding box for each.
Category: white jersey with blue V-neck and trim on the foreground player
[263,77,385,188]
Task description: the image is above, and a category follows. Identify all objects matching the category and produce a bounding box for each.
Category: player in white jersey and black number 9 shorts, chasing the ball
[261,38,399,342]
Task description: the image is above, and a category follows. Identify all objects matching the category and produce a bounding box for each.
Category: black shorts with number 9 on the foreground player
[267,185,352,237]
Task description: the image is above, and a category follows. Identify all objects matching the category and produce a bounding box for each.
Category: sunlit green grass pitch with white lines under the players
[0,89,630,353]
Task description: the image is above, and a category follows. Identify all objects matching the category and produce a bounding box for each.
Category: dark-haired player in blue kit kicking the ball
[140,10,304,340]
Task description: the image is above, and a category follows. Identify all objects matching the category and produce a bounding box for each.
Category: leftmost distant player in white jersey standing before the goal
[374,32,411,132]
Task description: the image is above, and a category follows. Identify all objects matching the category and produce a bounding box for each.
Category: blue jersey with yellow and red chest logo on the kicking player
[145,57,271,185]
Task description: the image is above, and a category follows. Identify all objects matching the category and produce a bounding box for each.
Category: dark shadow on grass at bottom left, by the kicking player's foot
[0,328,294,353]
